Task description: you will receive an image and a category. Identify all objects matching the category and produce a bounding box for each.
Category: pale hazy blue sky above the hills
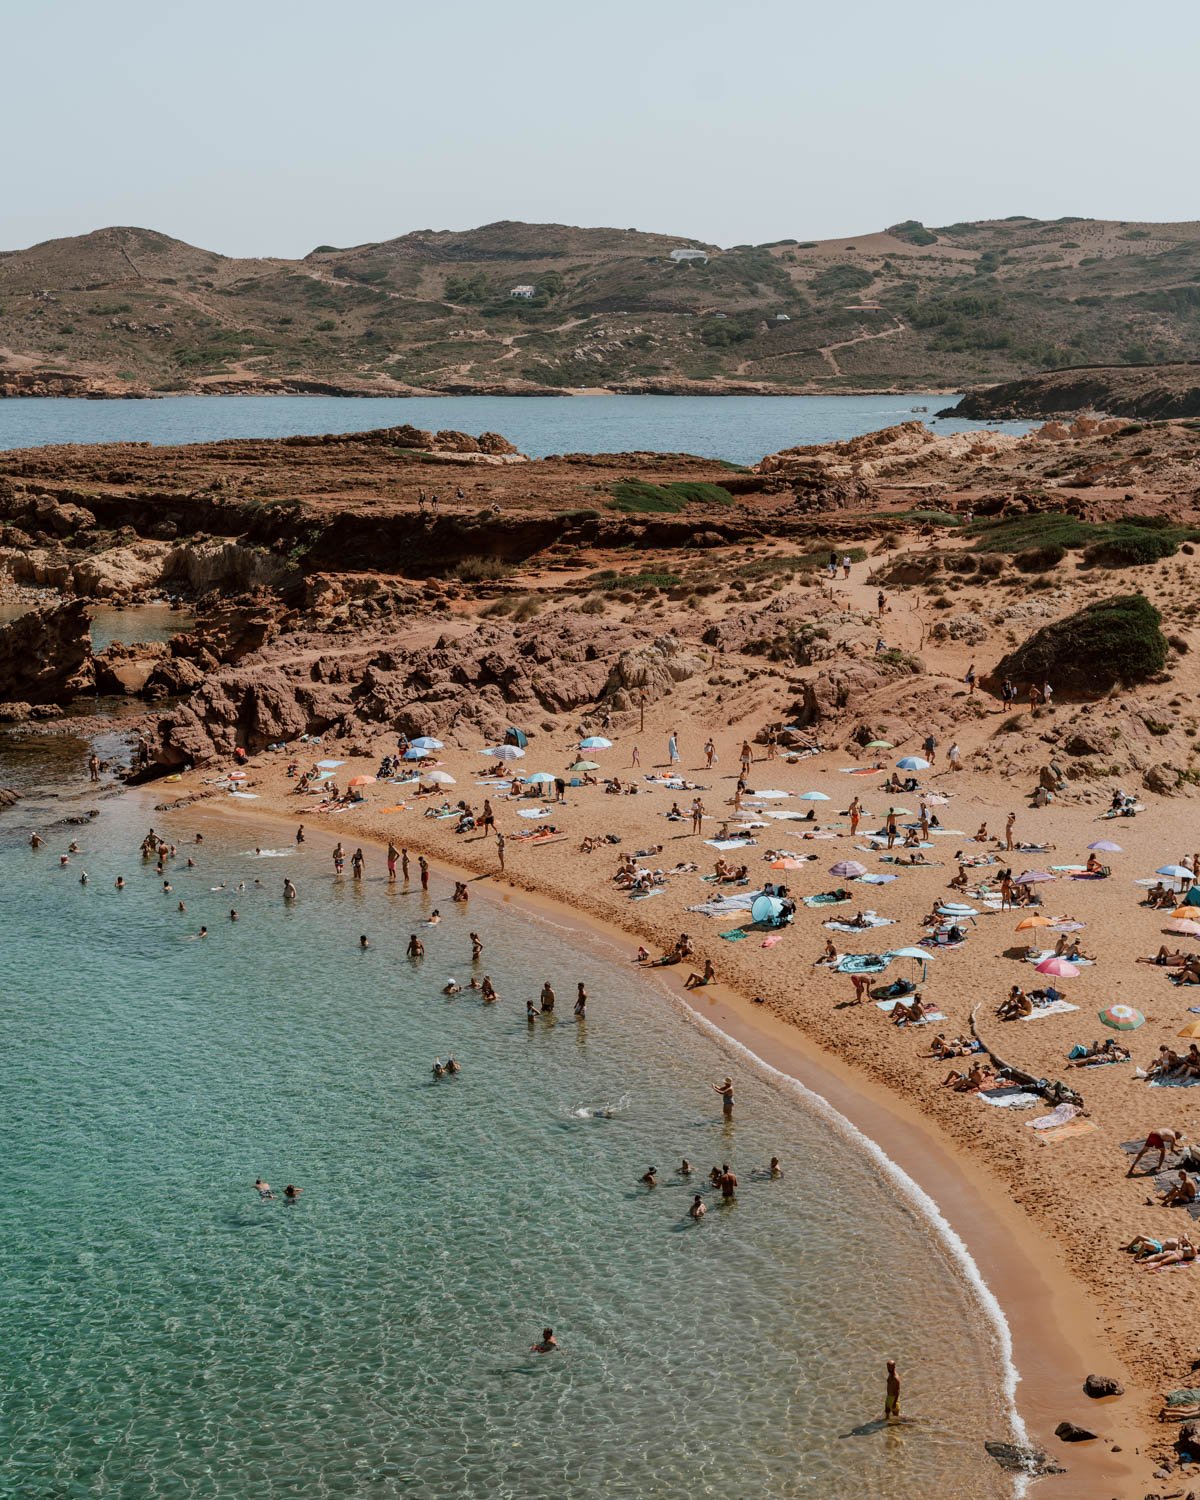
[9,0,1200,255]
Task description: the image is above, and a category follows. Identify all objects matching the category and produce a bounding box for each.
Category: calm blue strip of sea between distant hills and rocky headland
[0,392,1032,464]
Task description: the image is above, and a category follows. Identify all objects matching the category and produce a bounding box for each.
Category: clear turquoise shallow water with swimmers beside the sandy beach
[0,774,1008,1500]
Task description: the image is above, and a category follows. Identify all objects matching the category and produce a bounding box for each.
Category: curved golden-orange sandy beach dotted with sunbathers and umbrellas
[166,687,1197,1497]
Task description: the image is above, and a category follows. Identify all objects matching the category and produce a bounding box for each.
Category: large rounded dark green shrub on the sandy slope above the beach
[996,594,1167,693]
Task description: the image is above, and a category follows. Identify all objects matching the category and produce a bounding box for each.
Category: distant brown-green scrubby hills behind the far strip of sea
[0,218,1200,393]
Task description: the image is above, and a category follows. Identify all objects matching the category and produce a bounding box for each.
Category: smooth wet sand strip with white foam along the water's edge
[180,788,1146,1500]
